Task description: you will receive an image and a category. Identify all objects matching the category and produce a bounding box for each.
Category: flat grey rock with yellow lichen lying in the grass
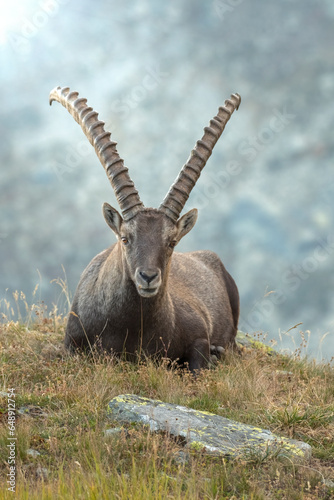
[108,394,311,459]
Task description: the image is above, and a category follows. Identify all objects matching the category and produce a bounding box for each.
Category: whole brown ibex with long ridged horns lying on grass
[50,87,241,372]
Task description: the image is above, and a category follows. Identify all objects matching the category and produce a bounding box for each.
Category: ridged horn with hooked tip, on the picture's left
[49,87,144,220]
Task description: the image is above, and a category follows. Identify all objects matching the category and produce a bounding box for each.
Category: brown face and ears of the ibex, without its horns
[103,203,197,298]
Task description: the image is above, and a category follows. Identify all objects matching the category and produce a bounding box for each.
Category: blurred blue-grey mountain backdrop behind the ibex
[0,0,334,359]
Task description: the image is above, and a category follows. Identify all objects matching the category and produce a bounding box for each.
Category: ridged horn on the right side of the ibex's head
[159,94,241,221]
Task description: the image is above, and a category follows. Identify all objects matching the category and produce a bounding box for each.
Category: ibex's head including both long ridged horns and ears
[50,87,241,298]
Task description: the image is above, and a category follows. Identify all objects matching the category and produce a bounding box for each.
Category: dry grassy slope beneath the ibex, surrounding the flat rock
[0,298,334,500]
